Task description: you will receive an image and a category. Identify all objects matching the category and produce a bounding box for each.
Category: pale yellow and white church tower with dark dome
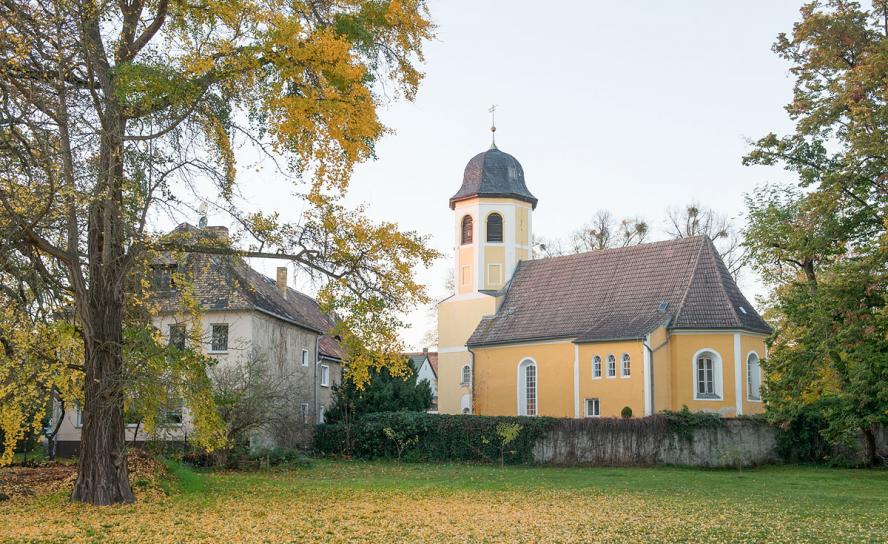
[438,127,537,414]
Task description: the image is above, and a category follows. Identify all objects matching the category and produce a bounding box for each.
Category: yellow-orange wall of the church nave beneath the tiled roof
[462,328,764,417]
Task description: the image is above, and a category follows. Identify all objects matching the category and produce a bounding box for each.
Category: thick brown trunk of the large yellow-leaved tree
[71,111,136,505]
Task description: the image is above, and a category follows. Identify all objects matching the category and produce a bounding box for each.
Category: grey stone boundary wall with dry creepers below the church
[533,418,779,468]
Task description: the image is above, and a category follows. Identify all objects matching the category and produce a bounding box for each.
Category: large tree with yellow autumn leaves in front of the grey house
[0,0,435,504]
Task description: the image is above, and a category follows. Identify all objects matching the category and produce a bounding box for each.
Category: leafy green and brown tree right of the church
[744,0,888,464]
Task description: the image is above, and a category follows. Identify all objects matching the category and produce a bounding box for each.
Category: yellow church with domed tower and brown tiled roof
[437,137,771,418]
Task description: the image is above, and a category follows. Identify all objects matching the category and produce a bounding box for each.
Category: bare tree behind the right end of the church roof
[666,202,749,279]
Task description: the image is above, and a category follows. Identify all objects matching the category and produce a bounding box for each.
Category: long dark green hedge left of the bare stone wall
[314,412,557,464]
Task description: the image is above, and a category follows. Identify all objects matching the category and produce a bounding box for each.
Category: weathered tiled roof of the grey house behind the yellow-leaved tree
[156,223,343,359]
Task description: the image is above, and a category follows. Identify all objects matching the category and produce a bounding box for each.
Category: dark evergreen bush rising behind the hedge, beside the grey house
[326,365,432,423]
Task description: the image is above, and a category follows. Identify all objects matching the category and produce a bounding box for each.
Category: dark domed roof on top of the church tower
[450,146,537,208]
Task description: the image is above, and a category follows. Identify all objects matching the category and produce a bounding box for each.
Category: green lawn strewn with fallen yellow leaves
[0,461,888,543]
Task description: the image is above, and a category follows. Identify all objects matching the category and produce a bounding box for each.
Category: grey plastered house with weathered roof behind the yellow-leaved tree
[56,224,343,456]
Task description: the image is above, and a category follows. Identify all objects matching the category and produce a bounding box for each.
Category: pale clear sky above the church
[239,0,802,349]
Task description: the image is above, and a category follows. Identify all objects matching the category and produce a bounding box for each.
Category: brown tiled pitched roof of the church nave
[467,236,771,346]
